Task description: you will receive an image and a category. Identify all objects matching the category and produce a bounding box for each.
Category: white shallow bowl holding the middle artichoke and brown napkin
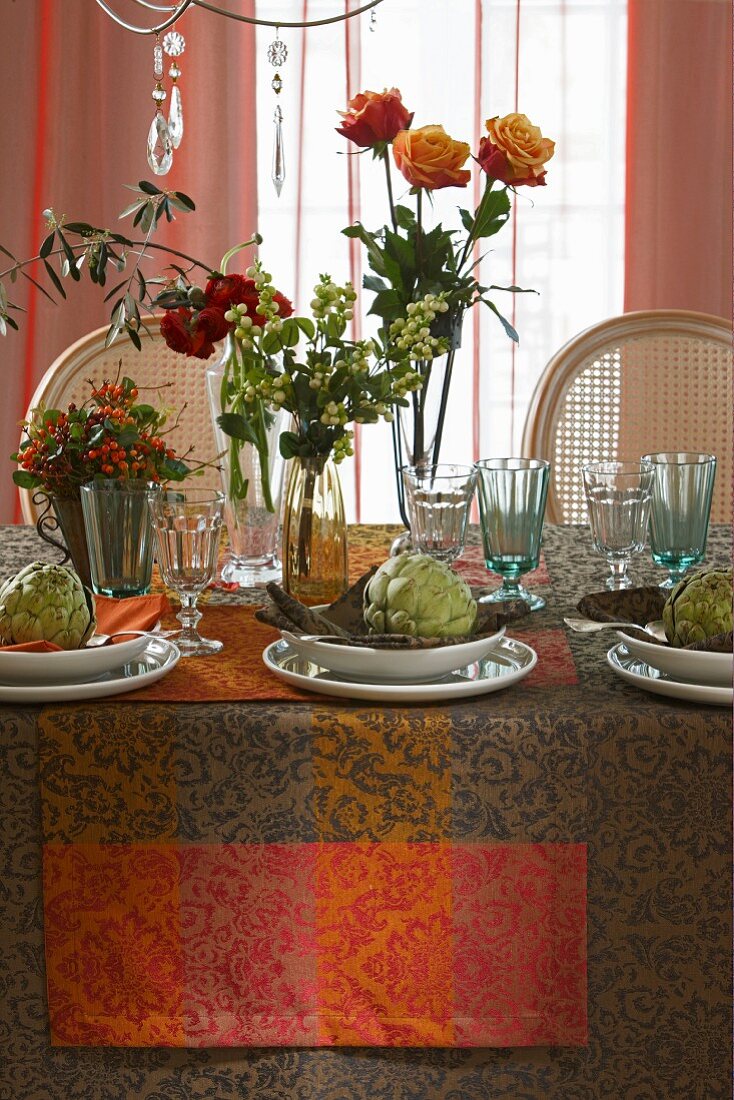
[281,627,505,684]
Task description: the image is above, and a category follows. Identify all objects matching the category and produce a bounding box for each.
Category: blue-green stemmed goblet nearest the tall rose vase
[475,459,550,612]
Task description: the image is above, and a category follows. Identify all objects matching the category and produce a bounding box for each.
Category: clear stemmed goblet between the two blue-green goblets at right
[582,462,655,590]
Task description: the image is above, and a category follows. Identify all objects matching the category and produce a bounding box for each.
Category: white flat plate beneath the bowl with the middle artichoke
[263,638,538,703]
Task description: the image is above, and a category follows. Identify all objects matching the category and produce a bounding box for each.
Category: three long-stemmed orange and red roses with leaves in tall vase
[337,88,555,526]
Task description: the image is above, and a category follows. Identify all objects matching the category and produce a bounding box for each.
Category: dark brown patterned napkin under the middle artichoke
[255,567,528,649]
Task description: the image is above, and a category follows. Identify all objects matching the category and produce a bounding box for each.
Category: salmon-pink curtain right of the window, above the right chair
[625,0,732,317]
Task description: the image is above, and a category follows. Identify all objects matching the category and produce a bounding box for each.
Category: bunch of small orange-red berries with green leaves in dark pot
[11,377,194,499]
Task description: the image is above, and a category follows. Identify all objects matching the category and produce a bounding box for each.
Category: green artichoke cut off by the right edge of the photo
[662,569,732,648]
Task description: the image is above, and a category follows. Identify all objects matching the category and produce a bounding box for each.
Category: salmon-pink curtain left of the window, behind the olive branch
[0,0,258,523]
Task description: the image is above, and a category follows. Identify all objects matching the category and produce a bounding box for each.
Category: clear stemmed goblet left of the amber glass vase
[149,488,224,657]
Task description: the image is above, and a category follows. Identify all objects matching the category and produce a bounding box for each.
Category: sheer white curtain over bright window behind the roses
[256,0,626,523]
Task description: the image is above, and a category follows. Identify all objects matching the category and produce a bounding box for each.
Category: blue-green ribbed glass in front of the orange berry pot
[80,477,158,598]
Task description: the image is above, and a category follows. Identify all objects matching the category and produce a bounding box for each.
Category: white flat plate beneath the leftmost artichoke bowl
[0,637,180,703]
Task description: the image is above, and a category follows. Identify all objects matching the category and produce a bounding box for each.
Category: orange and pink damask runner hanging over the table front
[40,538,587,1047]
